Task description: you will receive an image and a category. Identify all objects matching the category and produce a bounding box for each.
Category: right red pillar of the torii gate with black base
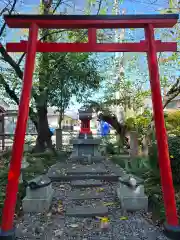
[145,24,180,239]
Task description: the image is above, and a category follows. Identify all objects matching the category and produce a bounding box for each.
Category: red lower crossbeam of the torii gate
[6,41,177,52]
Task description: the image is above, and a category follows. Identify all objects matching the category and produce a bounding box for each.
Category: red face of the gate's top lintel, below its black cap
[5,17,177,29]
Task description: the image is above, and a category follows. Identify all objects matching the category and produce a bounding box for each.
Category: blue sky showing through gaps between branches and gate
[0,0,179,108]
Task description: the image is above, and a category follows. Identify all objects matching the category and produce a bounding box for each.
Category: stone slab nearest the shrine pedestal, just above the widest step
[67,164,108,175]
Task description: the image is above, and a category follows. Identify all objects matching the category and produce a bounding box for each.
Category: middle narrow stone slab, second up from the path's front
[67,189,104,200]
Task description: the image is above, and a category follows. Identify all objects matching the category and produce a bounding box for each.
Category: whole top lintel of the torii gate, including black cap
[4,14,179,29]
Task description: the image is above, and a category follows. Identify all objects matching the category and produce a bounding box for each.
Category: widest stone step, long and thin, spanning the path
[48,174,120,182]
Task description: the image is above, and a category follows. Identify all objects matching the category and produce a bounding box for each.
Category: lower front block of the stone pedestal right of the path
[120,196,148,211]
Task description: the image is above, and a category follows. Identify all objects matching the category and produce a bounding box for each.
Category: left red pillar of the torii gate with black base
[0,23,38,240]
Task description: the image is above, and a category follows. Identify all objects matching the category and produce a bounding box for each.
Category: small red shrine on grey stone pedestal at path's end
[71,107,104,163]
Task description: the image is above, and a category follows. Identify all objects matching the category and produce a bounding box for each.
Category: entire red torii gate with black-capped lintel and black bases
[0,14,179,239]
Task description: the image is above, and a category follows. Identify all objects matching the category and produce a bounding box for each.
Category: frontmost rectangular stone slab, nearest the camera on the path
[66,205,108,217]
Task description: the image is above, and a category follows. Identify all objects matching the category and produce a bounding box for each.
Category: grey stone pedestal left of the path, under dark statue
[22,189,54,213]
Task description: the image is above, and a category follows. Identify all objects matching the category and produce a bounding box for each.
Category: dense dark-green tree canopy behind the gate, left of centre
[36,26,102,124]
